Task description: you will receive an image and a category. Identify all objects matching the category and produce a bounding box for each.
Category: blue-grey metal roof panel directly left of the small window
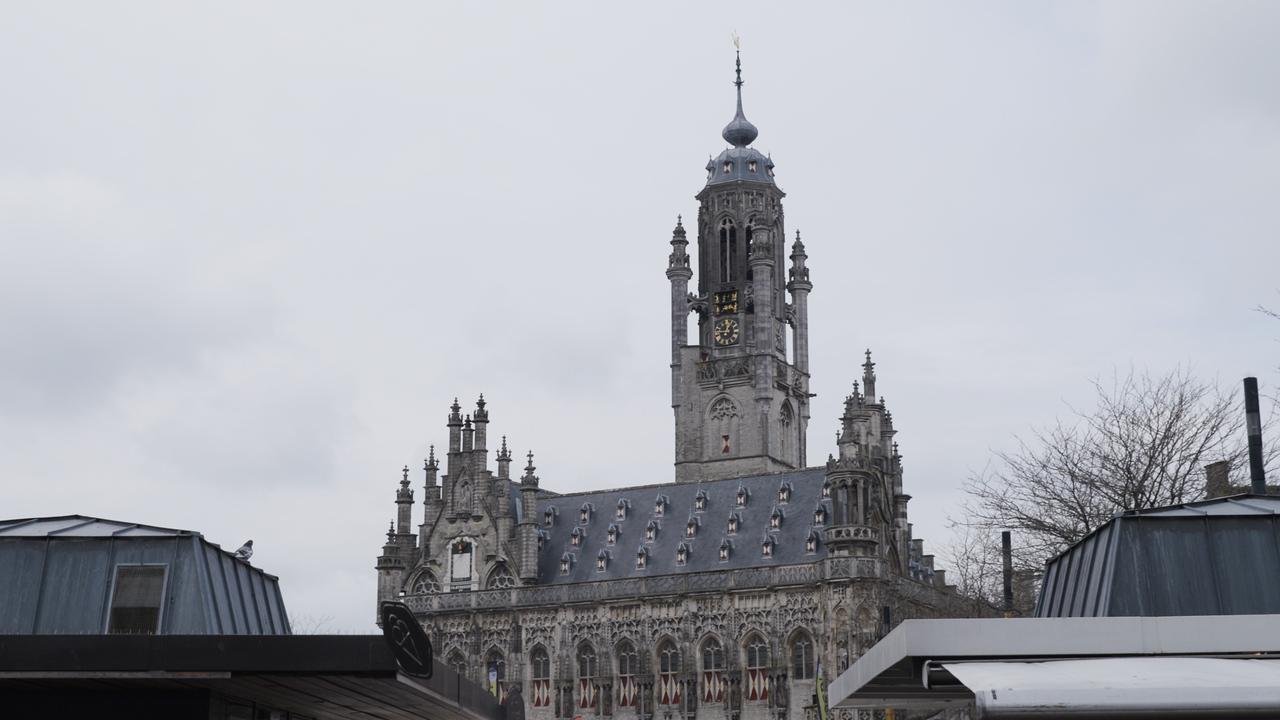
[35,539,111,634]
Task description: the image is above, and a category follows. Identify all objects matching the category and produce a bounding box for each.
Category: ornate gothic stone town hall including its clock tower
[378,54,961,720]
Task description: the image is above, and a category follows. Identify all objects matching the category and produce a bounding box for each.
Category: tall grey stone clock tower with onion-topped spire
[667,51,813,482]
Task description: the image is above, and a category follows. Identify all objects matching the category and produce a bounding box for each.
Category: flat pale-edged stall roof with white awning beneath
[829,615,1280,717]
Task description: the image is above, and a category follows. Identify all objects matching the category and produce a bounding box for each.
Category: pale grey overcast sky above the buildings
[0,0,1280,632]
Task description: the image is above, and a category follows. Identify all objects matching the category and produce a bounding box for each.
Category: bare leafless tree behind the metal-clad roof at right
[957,369,1276,574]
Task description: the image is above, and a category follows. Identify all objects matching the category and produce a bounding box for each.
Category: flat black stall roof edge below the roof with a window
[0,635,506,720]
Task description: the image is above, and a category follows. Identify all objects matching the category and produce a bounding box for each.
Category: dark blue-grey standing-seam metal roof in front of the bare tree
[1036,495,1280,618]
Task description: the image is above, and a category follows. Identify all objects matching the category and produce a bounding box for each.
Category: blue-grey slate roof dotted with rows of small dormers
[538,468,831,585]
